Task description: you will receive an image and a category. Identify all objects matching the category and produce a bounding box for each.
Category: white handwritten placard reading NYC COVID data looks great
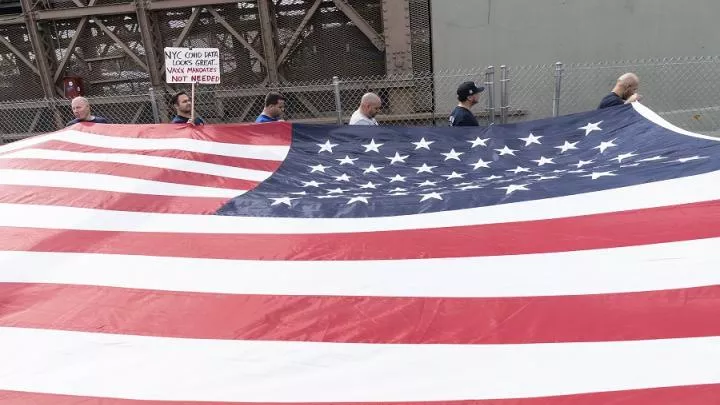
[165,47,220,84]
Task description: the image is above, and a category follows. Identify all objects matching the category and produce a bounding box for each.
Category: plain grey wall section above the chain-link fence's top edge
[431,0,720,71]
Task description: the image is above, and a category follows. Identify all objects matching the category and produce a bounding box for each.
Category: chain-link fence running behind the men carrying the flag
[0,57,720,142]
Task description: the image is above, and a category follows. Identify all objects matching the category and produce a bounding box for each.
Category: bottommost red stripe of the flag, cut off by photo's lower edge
[0,384,720,405]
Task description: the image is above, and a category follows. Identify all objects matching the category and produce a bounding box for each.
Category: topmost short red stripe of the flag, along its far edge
[68,122,292,145]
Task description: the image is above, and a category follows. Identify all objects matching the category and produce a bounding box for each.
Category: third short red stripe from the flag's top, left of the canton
[0,159,259,189]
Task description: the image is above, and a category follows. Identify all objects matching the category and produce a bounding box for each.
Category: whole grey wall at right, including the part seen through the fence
[431,0,720,130]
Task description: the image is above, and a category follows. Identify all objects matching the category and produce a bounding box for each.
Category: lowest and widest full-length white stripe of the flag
[0,328,720,402]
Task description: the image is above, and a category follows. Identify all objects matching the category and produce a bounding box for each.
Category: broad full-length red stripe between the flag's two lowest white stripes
[0,282,720,344]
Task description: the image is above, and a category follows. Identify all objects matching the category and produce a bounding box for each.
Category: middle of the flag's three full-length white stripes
[0,238,720,297]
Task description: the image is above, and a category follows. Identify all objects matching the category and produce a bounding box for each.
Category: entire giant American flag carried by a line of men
[0,103,720,405]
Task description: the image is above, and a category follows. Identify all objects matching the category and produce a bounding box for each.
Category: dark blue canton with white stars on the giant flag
[218,105,720,217]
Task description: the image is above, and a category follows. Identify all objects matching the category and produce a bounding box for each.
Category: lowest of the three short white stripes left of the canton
[0,169,247,197]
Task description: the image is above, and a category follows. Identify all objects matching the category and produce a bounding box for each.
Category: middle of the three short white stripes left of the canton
[0,149,272,181]
